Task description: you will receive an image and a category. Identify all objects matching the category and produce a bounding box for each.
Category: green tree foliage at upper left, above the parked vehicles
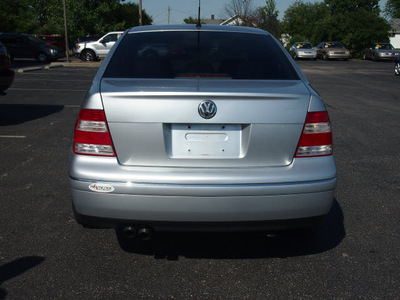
[0,0,152,40]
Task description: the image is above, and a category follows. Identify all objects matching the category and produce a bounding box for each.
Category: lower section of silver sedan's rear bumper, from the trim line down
[70,178,337,230]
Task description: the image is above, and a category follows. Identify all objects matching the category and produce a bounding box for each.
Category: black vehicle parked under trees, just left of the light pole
[0,33,65,62]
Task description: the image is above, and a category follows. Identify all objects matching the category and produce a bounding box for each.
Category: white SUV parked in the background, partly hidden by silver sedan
[75,31,124,61]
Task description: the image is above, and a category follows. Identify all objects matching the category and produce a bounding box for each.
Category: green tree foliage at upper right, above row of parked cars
[284,0,390,56]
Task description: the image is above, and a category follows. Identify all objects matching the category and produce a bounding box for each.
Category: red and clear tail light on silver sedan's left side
[73,109,115,156]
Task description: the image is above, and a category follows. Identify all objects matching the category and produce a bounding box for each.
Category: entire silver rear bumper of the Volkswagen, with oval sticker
[69,154,337,231]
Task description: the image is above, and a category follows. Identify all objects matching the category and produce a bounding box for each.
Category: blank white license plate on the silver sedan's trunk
[171,124,242,159]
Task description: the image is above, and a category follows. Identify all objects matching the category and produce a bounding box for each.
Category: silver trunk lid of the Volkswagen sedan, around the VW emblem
[101,78,310,168]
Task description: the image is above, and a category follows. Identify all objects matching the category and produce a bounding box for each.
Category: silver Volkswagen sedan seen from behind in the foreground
[69,25,337,236]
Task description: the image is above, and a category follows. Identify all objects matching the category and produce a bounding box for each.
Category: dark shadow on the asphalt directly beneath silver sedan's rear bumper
[117,199,346,260]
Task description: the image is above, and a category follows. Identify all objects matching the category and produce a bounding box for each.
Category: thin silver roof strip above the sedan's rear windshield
[128,24,269,35]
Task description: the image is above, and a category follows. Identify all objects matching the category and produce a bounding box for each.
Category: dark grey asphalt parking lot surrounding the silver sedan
[0,60,400,299]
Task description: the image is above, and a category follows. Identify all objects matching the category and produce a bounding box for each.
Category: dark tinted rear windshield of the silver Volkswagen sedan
[104,31,299,80]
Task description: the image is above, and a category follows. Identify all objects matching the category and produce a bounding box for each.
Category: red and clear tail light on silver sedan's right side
[295,111,333,157]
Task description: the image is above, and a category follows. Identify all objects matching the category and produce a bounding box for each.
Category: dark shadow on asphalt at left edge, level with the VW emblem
[0,104,64,126]
